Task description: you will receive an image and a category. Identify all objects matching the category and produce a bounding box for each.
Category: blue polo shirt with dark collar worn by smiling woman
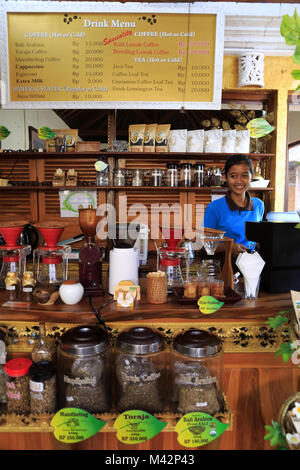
[203,192,264,247]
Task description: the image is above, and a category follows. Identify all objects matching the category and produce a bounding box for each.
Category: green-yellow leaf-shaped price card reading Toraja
[114,410,167,444]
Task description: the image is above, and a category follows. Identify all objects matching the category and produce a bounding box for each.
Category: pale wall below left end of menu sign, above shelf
[0,109,68,150]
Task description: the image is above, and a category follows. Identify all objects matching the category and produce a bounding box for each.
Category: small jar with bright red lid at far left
[4,358,32,414]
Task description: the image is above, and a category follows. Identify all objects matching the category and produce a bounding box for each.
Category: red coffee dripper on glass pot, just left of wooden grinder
[33,222,71,287]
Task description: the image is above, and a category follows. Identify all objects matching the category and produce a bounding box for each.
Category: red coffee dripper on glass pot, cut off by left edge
[0,221,31,288]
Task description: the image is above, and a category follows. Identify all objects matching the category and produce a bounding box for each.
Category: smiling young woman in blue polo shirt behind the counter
[203,155,264,256]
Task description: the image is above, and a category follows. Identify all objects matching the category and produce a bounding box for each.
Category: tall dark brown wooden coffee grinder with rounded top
[78,205,105,297]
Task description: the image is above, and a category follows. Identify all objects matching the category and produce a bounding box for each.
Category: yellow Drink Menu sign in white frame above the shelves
[1,2,224,109]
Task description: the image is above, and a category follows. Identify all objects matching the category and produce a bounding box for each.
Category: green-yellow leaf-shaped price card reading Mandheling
[50,408,106,444]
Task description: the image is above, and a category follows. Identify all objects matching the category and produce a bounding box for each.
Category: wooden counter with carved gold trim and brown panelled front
[0,286,300,451]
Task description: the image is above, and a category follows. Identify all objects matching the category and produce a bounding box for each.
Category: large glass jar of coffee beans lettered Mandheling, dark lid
[57,325,111,413]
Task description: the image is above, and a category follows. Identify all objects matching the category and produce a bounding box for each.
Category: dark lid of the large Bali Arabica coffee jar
[173,330,222,357]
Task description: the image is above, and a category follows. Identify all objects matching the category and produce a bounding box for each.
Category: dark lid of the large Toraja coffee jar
[117,326,165,354]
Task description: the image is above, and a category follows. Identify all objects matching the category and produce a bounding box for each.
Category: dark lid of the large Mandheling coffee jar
[60,325,109,356]
